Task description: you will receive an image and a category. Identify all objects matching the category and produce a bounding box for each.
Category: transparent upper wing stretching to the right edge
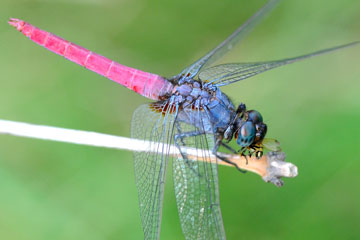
[199,41,359,87]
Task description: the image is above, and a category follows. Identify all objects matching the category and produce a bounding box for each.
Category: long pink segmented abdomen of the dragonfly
[9,18,173,100]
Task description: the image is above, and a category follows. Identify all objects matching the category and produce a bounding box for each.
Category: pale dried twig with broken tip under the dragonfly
[0,120,297,187]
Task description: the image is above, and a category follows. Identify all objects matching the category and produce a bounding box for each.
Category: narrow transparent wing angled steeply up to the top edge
[175,0,280,82]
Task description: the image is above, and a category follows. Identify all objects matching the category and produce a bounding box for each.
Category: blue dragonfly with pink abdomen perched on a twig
[9,0,359,240]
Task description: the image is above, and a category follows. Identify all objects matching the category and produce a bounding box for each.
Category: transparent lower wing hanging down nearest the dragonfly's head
[173,108,225,240]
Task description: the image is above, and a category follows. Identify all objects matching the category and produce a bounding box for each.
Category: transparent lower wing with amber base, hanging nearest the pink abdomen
[131,103,175,240]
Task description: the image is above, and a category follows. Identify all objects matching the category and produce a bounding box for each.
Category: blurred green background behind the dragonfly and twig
[0,0,360,240]
